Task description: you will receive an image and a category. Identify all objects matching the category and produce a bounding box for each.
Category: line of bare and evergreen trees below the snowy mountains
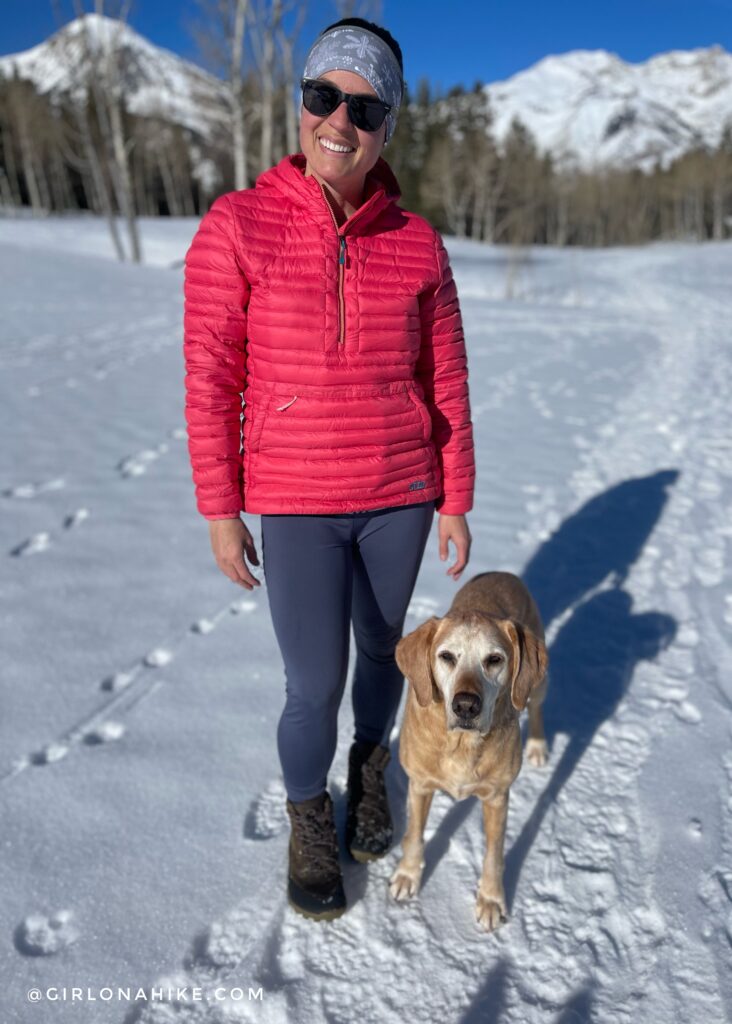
[0,0,732,260]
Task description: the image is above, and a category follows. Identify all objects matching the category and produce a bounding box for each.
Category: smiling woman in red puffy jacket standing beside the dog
[184,18,475,919]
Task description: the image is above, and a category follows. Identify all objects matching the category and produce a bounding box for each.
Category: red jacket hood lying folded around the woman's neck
[255,153,401,229]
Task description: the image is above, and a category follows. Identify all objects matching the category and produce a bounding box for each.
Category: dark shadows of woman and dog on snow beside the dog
[392,470,679,907]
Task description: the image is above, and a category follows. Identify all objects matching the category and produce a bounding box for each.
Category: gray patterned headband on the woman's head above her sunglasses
[303,25,403,142]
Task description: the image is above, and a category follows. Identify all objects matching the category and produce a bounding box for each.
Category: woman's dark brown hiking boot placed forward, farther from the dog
[287,791,346,921]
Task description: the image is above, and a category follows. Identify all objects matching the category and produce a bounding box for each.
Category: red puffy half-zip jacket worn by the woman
[184,154,475,519]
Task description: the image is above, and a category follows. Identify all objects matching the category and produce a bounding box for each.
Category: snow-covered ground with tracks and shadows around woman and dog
[0,219,732,1024]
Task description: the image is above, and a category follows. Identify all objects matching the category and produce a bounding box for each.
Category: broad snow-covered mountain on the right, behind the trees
[486,46,732,169]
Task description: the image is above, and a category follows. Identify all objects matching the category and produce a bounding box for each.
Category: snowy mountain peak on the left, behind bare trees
[0,14,227,136]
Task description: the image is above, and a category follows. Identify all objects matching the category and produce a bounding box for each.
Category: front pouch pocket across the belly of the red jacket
[250,381,432,475]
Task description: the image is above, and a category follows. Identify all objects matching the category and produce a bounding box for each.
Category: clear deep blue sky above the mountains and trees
[0,0,732,88]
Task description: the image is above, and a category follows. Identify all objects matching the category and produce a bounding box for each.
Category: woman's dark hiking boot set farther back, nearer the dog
[346,739,394,861]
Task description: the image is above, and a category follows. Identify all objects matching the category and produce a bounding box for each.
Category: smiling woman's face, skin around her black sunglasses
[300,71,386,194]
